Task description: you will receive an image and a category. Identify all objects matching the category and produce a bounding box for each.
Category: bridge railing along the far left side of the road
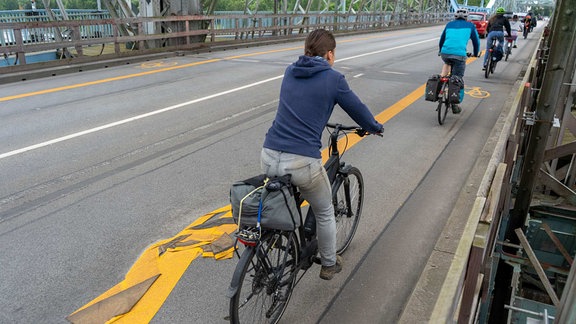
[0,12,452,65]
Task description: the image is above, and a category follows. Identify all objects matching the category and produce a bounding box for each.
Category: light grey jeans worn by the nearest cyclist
[260,148,336,266]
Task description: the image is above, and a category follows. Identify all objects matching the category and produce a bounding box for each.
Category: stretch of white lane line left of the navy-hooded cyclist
[0,75,284,159]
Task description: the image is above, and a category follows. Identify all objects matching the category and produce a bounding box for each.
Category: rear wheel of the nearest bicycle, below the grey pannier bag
[229,232,299,324]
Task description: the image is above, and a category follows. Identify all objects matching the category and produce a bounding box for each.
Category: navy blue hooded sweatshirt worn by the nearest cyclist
[264,55,382,159]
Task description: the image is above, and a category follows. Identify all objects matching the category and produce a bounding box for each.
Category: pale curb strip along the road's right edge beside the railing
[398,72,527,324]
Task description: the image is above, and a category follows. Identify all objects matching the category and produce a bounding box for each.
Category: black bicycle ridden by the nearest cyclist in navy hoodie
[227,123,382,324]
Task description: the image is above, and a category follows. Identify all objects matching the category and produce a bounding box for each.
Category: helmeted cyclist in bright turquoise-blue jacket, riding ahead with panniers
[439,9,480,114]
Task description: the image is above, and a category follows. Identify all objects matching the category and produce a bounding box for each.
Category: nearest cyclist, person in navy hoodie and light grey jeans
[261,29,383,280]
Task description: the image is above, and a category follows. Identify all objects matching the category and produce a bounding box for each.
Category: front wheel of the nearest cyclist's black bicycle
[332,167,364,254]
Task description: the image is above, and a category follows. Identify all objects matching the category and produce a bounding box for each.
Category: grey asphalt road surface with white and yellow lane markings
[0,26,537,323]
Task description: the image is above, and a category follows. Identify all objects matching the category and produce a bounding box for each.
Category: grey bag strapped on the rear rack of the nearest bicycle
[230,174,301,231]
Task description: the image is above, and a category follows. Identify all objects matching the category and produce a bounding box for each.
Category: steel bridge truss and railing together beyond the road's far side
[0,0,452,70]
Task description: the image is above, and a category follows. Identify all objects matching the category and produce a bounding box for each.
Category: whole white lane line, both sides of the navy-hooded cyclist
[0,38,438,160]
